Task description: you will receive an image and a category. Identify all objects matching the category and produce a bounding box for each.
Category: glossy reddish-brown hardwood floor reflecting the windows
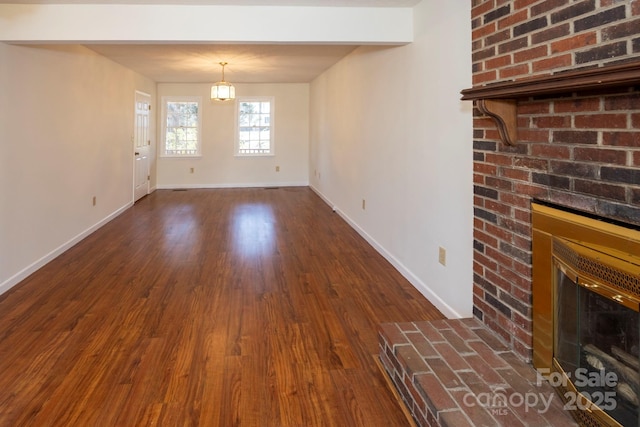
[0,188,443,427]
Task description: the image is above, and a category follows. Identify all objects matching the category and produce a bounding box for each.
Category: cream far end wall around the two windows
[156,84,309,188]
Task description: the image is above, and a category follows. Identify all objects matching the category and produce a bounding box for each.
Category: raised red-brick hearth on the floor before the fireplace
[379,319,577,427]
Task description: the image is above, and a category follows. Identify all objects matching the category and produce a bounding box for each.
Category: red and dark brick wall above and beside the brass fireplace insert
[472,0,640,359]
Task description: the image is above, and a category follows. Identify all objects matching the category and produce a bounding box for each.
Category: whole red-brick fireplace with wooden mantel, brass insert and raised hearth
[380,0,640,426]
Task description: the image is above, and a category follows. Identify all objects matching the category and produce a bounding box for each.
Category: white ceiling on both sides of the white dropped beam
[0,0,420,83]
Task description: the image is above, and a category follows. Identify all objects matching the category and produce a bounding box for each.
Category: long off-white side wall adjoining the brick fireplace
[310,1,473,317]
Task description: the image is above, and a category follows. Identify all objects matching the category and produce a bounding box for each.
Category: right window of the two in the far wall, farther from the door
[236,97,274,156]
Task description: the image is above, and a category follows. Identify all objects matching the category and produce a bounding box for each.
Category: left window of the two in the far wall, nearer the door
[161,96,202,157]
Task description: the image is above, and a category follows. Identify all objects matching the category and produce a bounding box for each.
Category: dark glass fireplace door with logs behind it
[554,242,640,426]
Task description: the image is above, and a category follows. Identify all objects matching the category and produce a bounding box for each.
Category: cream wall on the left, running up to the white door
[0,43,155,293]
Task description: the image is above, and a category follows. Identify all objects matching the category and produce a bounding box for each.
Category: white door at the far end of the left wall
[133,91,151,202]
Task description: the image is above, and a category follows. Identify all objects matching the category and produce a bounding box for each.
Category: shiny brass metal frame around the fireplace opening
[532,202,640,425]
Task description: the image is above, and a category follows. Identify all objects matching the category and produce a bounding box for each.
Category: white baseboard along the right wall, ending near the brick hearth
[309,185,464,319]
